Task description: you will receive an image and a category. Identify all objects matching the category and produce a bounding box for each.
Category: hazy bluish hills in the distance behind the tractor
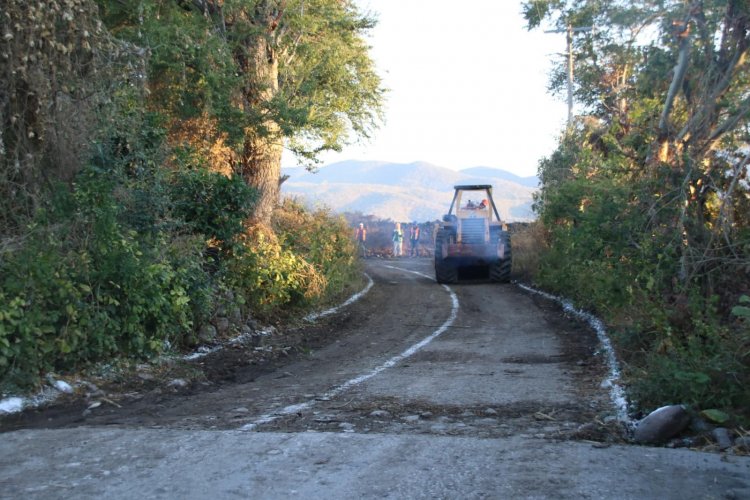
[282,161,537,221]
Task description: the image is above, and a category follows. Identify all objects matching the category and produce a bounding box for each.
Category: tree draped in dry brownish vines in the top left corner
[0,0,132,236]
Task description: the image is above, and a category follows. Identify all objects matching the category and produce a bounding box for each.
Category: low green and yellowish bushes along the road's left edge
[0,165,359,389]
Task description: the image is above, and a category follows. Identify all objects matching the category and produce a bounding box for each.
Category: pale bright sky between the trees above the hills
[284,0,567,176]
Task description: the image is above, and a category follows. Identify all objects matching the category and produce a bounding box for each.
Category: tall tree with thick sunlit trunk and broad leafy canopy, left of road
[100,0,384,222]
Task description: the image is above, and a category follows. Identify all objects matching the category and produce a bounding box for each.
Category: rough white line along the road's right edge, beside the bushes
[516,283,634,427]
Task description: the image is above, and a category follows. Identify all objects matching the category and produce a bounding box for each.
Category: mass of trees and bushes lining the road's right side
[524,0,750,424]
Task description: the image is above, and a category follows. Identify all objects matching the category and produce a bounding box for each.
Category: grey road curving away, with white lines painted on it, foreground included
[0,259,750,498]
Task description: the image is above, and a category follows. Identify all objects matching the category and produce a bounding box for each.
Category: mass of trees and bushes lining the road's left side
[0,0,383,393]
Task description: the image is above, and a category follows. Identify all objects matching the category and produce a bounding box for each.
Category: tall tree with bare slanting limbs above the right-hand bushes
[524,0,750,283]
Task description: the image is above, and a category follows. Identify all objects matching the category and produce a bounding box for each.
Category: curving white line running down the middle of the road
[240,266,459,431]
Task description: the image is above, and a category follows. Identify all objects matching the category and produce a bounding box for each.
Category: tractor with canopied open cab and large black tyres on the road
[435,184,511,283]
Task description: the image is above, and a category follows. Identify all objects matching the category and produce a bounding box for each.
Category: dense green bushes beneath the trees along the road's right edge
[534,135,750,413]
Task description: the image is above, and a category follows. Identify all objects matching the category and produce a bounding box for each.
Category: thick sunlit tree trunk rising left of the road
[240,32,283,224]
